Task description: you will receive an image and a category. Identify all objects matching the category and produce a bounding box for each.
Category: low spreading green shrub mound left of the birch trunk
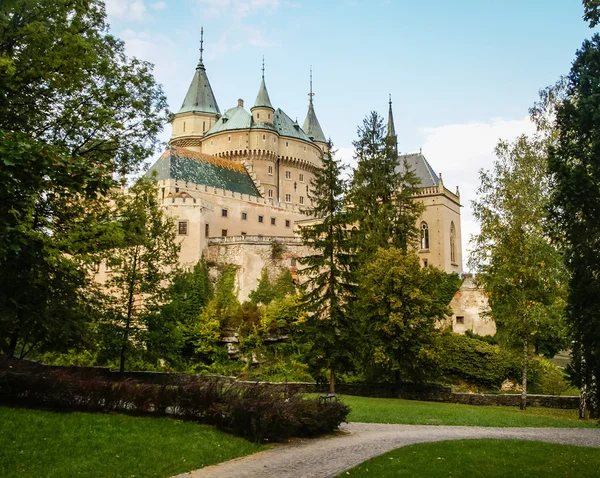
[437,333,520,388]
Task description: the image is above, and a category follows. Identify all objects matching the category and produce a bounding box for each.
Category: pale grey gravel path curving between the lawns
[176,423,600,478]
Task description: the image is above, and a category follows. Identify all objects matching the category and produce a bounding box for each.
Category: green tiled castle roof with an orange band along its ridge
[148,147,260,197]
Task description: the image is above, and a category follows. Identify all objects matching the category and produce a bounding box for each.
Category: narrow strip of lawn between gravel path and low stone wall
[340,395,598,428]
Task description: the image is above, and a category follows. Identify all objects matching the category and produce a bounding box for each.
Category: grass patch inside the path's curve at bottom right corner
[339,439,600,478]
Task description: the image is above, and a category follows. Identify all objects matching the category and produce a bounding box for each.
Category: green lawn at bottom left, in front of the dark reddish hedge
[0,407,265,477]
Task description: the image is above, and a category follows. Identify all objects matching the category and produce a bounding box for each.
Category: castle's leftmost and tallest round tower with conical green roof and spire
[171,28,221,151]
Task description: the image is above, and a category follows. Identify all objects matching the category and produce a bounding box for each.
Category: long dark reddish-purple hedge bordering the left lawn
[0,360,350,441]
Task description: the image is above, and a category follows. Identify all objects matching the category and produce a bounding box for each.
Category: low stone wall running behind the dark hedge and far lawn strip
[0,356,579,409]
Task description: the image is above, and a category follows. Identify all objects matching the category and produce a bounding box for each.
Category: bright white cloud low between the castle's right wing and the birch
[423,117,535,269]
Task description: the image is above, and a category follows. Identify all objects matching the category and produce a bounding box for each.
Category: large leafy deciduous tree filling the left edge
[0,0,168,355]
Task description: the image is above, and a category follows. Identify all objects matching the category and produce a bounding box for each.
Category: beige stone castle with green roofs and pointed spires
[151,31,462,300]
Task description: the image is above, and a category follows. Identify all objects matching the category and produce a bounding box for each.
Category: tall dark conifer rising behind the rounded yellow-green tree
[348,112,423,256]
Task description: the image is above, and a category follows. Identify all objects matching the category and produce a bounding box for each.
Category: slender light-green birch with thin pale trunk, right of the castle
[470,136,567,409]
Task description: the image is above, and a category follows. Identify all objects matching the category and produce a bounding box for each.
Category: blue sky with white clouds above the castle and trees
[105,0,594,270]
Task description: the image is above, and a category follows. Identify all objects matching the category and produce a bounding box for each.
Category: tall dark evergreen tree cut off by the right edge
[548,34,600,416]
